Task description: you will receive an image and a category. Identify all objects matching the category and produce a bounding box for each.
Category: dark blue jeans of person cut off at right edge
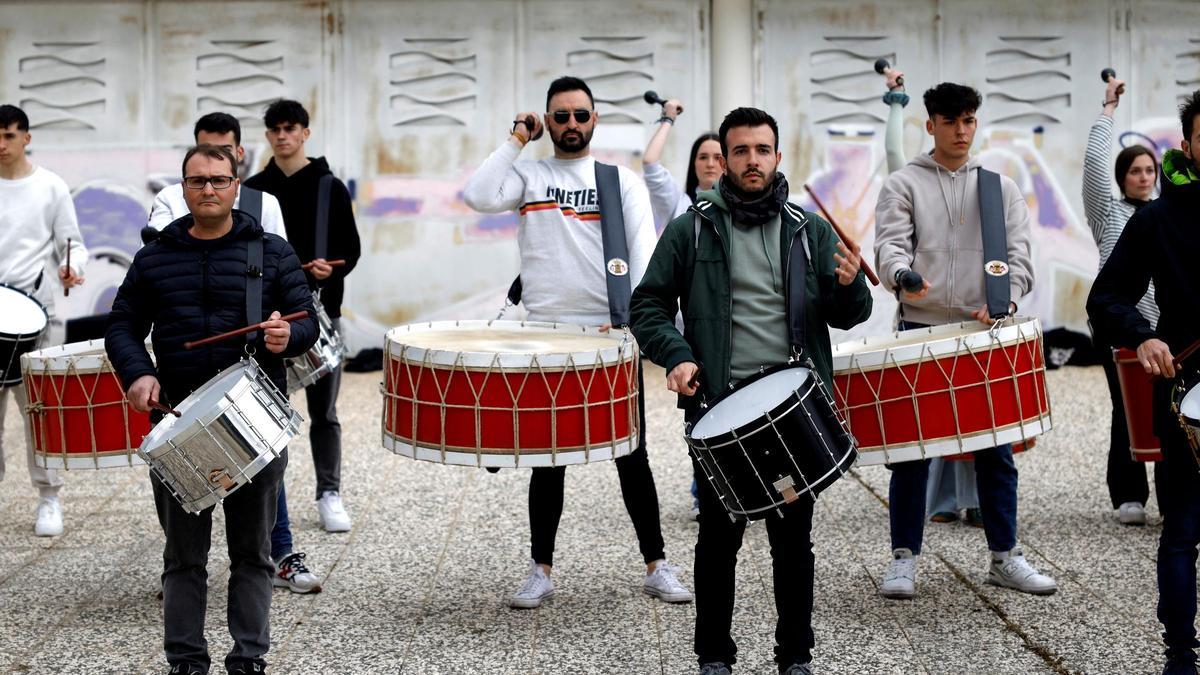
[1154,410,1200,661]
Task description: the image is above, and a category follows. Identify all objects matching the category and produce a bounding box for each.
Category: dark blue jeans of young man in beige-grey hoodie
[888,444,1016,555]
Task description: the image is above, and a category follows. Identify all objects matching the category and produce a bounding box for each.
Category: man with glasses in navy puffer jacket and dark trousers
[104,145,317,675]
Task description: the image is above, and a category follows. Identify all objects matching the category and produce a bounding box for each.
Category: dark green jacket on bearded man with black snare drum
[630,181,871,419]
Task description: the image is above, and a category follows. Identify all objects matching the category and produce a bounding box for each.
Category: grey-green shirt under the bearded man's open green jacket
[730,216,790,382]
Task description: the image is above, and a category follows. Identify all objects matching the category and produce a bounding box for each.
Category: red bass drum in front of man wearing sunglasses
[383,321,641,467]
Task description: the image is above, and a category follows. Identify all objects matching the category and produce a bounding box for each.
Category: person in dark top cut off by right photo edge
[1087,90,1200,674]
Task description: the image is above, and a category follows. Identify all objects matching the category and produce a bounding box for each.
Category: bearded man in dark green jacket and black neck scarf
[631,108,871,675]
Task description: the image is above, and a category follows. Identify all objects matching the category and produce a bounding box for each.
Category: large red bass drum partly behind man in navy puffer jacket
[20,340,154,468]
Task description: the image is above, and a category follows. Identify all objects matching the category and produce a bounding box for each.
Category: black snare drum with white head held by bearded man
[684,363,858,520]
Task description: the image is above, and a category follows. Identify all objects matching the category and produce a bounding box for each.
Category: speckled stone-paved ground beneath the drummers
[0,368,1162,674]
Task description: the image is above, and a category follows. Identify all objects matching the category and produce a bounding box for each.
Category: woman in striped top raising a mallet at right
[1084,77,1158,525]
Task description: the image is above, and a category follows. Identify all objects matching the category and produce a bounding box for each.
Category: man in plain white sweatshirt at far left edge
[0,106,88,537]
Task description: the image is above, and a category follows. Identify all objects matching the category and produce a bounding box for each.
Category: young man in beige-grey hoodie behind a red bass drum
[875,83,1057,598]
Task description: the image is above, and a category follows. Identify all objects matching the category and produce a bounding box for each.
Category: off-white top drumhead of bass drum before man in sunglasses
[404,329,613,354]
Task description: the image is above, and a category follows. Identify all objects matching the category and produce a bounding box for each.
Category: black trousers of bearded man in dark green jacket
[691,460,815,673]
